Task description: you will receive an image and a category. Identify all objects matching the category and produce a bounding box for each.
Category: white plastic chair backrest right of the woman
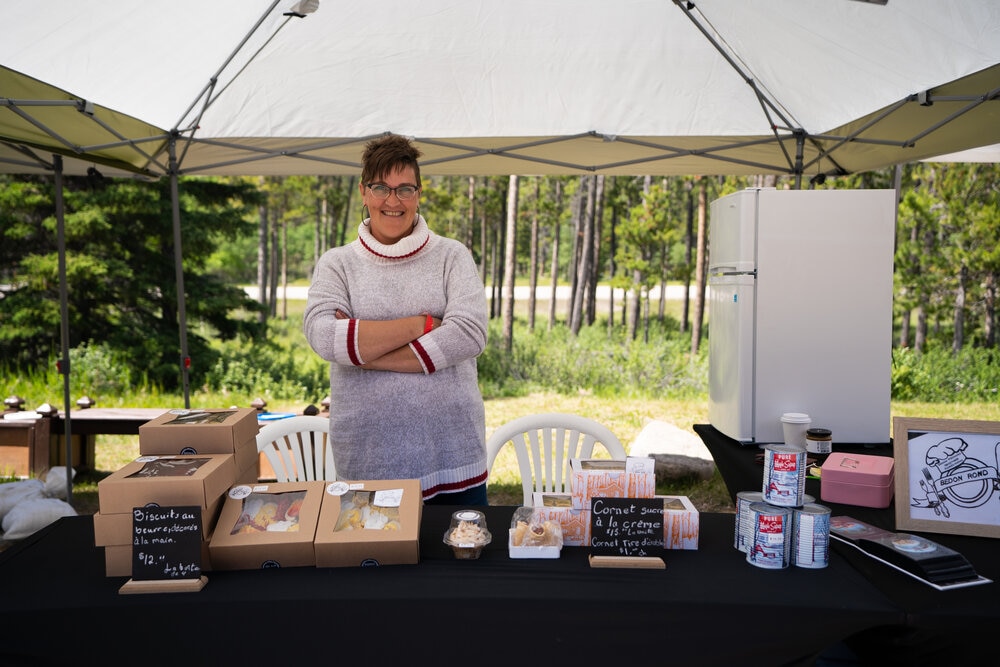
[486,412,625,506]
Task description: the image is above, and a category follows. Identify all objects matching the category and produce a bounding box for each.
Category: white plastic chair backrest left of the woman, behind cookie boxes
[257,415,337,482]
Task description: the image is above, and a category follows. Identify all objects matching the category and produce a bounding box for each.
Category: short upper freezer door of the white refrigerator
[708,188,760,275]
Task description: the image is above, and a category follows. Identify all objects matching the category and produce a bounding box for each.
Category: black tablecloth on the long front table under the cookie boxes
[0,506,905,667]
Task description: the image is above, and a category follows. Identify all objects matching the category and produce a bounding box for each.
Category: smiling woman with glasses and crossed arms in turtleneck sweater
[303,135,487,505]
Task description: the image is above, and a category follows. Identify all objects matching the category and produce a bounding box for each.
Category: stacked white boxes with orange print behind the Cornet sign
[532,456,699,549]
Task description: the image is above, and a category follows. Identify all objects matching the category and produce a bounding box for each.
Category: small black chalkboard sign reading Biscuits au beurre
[132,505,201,581]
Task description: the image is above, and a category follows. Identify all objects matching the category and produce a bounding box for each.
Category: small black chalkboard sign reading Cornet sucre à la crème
[590,498,663,557]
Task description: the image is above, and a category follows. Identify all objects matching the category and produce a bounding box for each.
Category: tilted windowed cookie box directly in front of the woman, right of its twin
[316,479,424,567]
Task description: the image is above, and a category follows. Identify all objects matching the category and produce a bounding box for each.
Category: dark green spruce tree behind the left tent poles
[0,177,257,390]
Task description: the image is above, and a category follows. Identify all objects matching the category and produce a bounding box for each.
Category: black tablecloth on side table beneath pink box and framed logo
[694,424,1000,664]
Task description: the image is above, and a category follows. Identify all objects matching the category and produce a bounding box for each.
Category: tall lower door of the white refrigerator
[708,274,755,442]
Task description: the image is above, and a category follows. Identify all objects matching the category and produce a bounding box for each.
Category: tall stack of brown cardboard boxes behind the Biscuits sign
[94,408,258,577]
